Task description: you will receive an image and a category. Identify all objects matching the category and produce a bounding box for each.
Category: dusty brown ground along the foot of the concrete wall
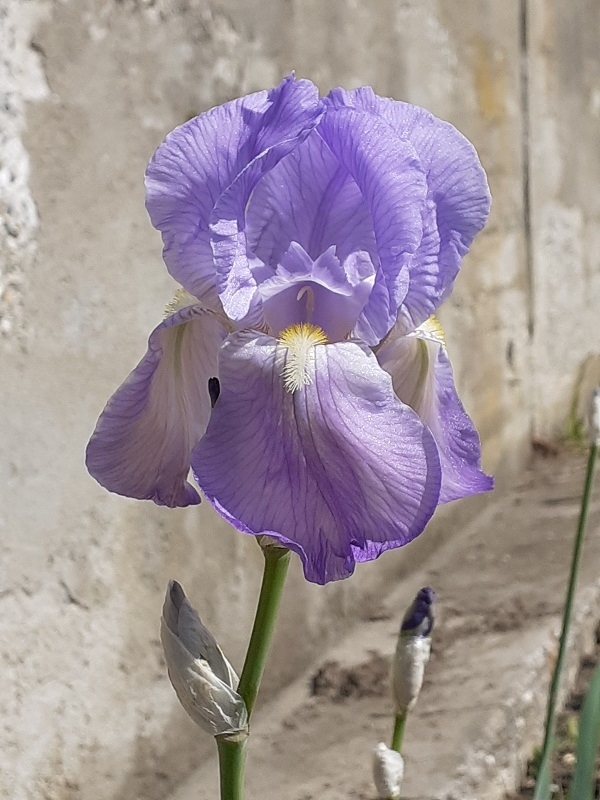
[168,446,600,800]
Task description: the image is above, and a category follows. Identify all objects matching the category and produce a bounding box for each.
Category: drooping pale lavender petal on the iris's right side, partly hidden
[377,324,493,503]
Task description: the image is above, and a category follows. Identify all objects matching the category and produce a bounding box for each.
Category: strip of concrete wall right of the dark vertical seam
[527,0,600,431]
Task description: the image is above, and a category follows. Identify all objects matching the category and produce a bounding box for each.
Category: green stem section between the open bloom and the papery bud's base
[238,546,290,717]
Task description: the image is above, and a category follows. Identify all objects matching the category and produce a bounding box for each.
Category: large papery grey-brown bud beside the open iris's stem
[160,581,248,736]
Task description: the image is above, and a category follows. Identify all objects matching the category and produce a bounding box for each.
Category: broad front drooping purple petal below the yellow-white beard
[192,332,440,583]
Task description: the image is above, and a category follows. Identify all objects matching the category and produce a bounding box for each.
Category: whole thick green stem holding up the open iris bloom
[217,546,290,800]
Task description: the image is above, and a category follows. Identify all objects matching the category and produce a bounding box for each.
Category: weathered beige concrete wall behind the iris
[0,0,600,800]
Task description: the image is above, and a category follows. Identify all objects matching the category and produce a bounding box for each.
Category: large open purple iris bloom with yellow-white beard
[87,77,492,583]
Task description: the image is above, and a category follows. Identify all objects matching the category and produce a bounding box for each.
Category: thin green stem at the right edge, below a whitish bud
[540,444,598,784]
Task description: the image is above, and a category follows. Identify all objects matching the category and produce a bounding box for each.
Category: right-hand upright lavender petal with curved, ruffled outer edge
[325,87,490,331]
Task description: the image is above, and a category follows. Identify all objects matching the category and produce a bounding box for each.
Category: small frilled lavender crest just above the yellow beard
[258,242,375,342]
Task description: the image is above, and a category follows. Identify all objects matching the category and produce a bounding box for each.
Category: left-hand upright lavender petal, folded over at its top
[146,77,320,304]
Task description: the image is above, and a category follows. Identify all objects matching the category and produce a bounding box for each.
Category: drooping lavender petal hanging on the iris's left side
[86,306,228,507]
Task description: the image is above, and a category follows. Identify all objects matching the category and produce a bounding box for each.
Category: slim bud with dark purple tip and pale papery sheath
[392,587,435,714]
